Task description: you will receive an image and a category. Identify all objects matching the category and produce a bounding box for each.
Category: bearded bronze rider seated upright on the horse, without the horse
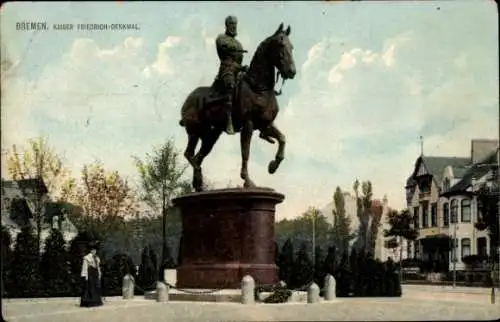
[215,16,247,134]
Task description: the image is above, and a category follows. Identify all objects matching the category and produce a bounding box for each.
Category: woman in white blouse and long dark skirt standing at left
[80,242,103,307]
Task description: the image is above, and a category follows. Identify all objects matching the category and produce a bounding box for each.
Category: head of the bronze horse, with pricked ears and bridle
[267,23,297,79]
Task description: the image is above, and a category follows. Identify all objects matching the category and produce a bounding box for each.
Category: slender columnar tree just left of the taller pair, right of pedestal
[332,187,355,252]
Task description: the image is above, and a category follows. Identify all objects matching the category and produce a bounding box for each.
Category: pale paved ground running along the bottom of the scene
[4,287,500,322]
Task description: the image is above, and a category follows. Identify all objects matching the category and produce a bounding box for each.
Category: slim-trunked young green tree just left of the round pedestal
[134,139,192,275]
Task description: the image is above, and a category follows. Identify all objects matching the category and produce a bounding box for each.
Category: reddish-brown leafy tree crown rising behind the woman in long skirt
[72,162,137,239]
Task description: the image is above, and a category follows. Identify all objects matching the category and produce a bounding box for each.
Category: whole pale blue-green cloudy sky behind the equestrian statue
[1,0,499,219]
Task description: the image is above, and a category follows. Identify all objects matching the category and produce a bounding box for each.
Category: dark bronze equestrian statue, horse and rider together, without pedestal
[179,16,296,192]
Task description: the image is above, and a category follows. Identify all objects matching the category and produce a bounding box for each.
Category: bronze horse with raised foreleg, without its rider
[179,23,296,191]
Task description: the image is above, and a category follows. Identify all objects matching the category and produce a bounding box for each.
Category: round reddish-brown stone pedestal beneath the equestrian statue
[173,188,284,289]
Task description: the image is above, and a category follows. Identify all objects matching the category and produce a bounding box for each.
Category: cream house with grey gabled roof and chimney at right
[404,139,498,272]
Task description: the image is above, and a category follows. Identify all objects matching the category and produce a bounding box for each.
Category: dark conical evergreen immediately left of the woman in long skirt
[40,229,71,296]
